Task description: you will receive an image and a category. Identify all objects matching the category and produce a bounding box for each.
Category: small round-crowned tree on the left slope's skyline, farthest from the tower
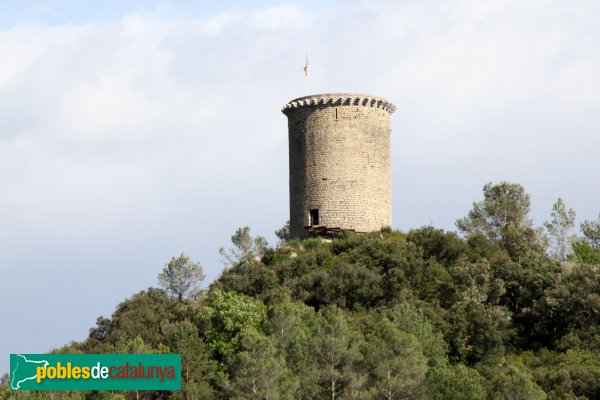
[158,253,205,301]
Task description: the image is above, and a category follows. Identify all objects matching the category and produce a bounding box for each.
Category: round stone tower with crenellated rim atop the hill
[281,93,396,237]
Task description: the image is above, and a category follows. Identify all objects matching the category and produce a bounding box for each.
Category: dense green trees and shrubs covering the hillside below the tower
[0,182,600,400]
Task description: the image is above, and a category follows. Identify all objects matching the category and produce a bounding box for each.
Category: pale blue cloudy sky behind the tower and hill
[0,0,600,373]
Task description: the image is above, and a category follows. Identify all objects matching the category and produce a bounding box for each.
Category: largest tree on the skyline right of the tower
[456,182,531,241]
